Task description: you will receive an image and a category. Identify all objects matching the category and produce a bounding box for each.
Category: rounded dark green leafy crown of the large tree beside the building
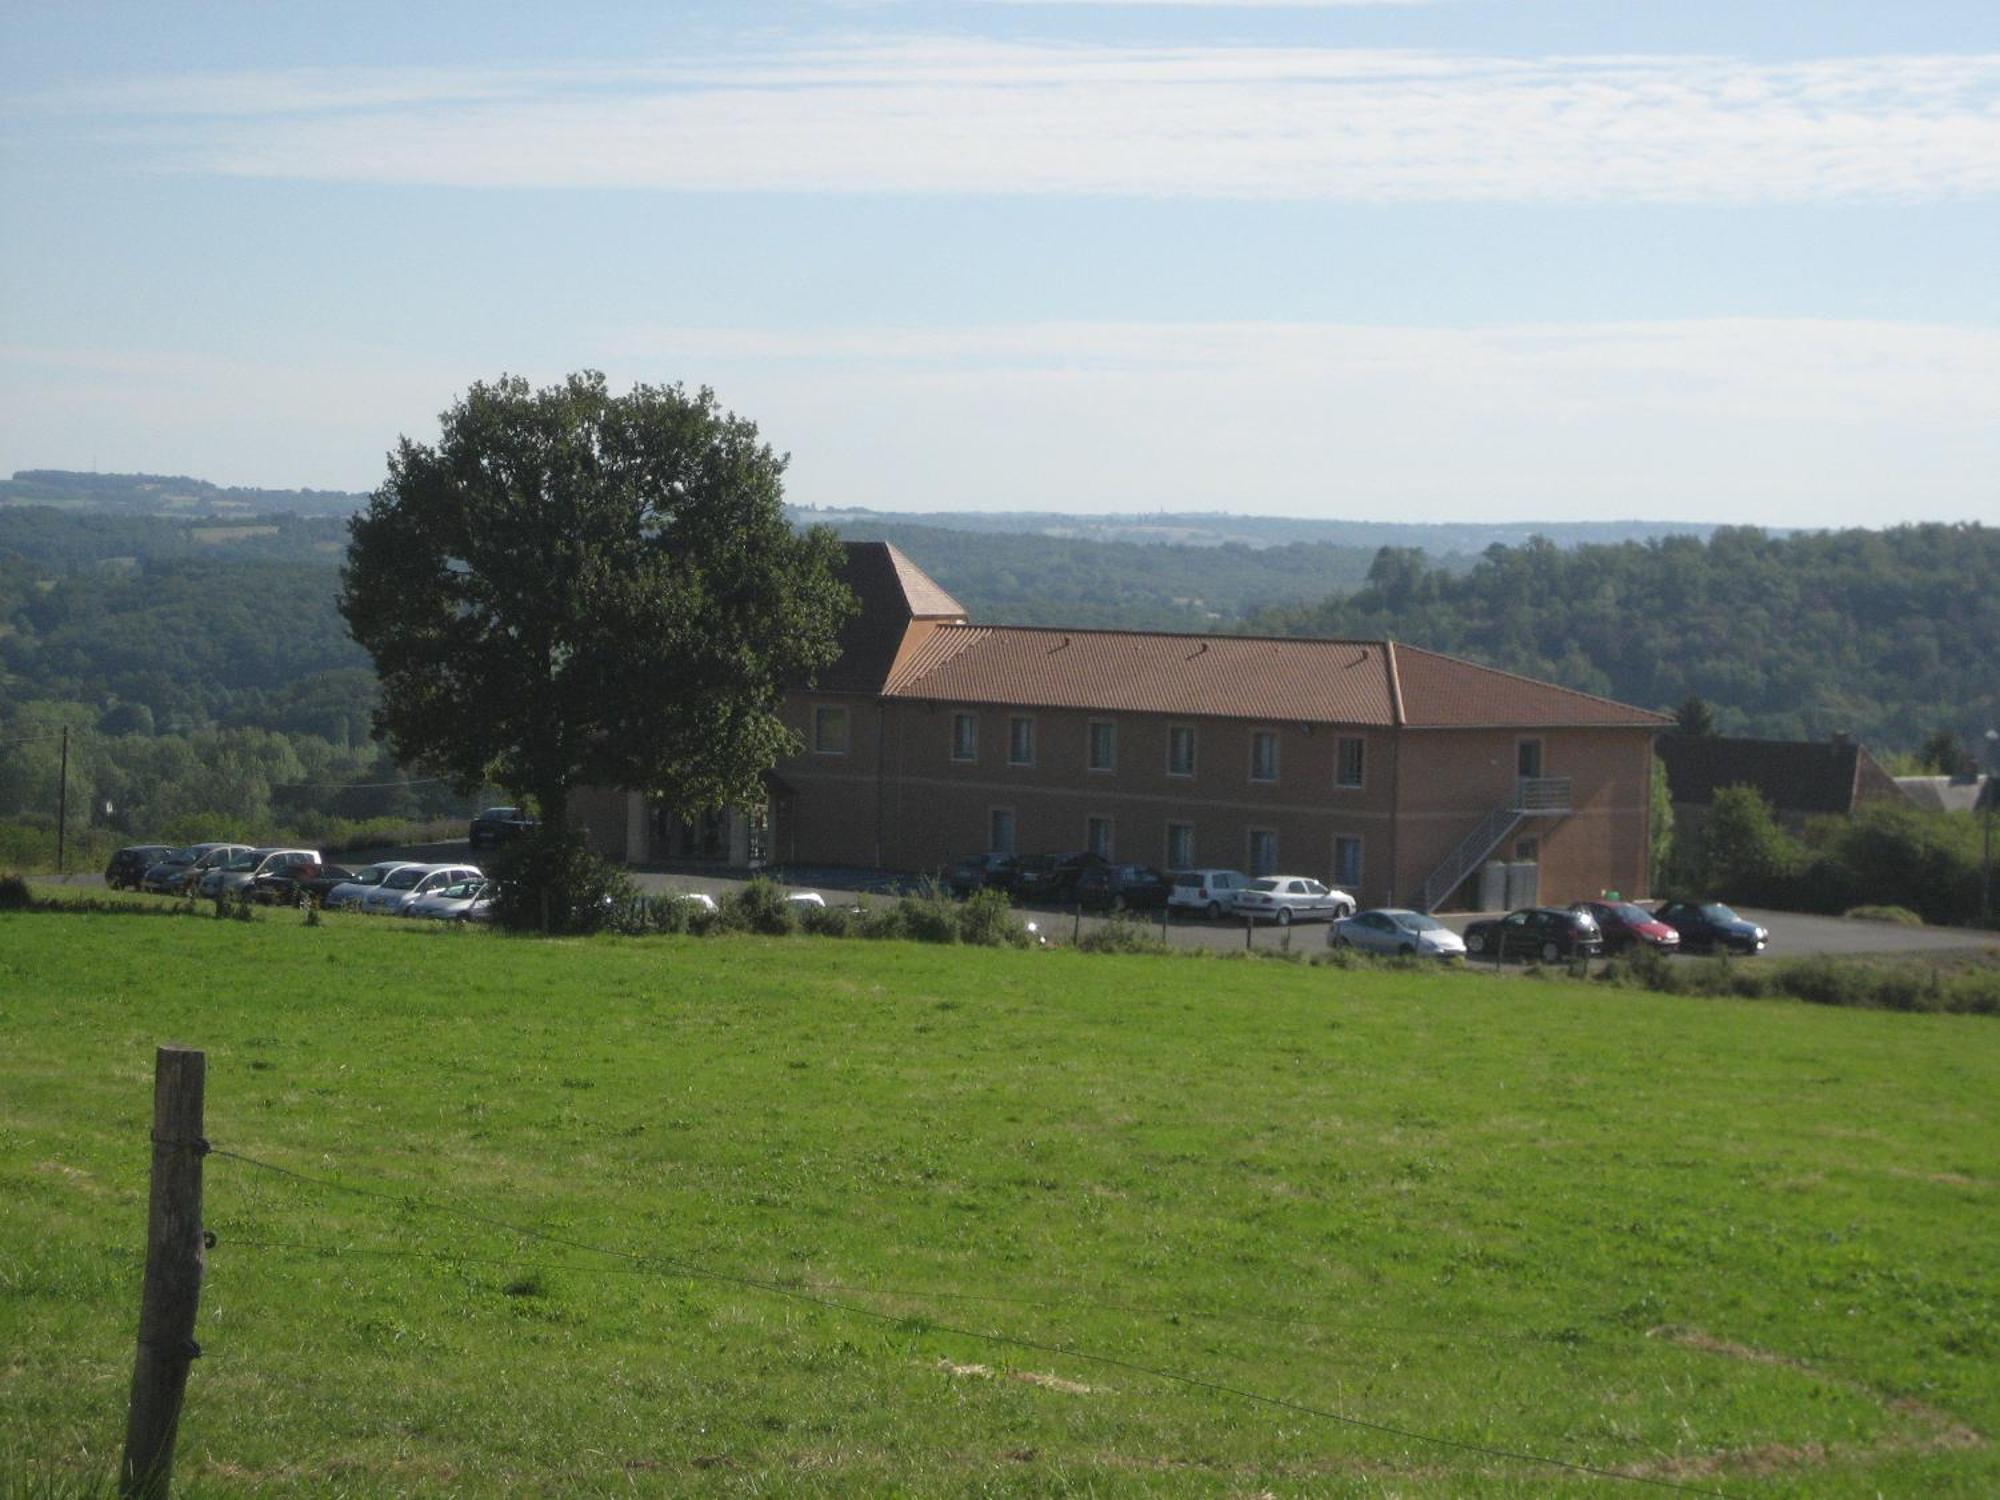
[340,372,854,832]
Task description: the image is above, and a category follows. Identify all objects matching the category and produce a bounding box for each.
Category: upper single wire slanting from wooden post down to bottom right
[210,1146,1732,1500]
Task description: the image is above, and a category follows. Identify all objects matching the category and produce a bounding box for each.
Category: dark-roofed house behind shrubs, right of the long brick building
[1658,734,1902,828]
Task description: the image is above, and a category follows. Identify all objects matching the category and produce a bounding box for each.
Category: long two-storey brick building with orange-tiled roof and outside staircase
[592,542,1670,908]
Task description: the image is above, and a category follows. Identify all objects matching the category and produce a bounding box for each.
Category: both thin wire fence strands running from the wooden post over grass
[206,1144,1732,1500]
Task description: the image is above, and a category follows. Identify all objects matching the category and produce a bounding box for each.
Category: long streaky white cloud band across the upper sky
[54,38,2000,202]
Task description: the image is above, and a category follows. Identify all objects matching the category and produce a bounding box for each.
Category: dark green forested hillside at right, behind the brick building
[1244,526,2000,748]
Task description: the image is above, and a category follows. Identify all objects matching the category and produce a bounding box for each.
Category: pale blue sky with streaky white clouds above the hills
[0,0,2000,526]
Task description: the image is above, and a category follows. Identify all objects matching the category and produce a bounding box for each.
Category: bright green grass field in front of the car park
[0,914,2000,1496]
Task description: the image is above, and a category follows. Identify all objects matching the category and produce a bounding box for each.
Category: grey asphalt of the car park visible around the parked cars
[64,838,2000,962]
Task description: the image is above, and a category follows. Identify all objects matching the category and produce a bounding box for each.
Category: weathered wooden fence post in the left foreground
[118,1046,208,1500]
